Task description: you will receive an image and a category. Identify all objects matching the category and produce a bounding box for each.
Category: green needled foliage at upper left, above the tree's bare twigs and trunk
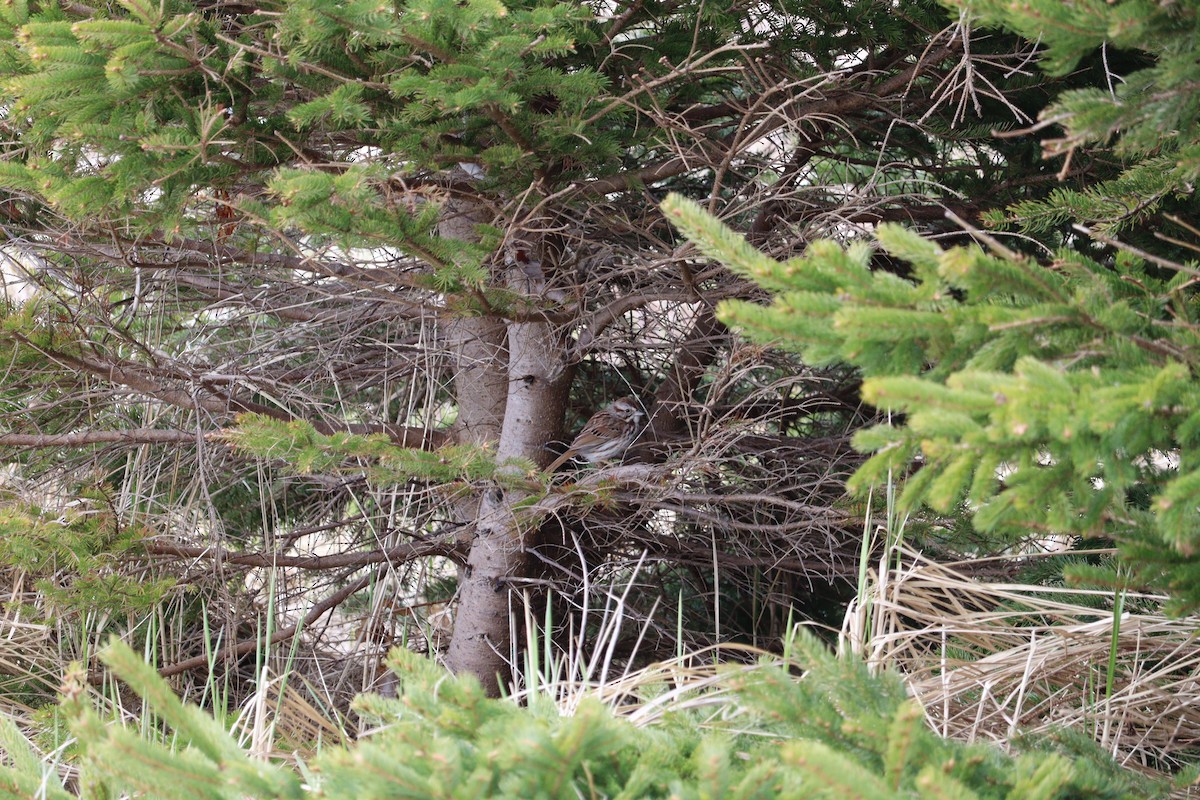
[0,0,816,314]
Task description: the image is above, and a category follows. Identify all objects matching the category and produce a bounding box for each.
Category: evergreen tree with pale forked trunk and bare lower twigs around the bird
[0,0,1104,691]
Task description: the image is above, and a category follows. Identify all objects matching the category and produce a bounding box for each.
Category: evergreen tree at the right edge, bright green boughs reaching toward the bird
[666,2,1200,610]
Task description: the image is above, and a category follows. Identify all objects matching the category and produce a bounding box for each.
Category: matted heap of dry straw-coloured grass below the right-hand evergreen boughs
[842,544,1200,796]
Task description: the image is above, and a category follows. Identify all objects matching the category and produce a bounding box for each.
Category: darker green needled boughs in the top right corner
[948,0,1200,233]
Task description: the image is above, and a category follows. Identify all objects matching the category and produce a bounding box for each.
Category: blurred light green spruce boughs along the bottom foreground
[0,632,1165,800]
